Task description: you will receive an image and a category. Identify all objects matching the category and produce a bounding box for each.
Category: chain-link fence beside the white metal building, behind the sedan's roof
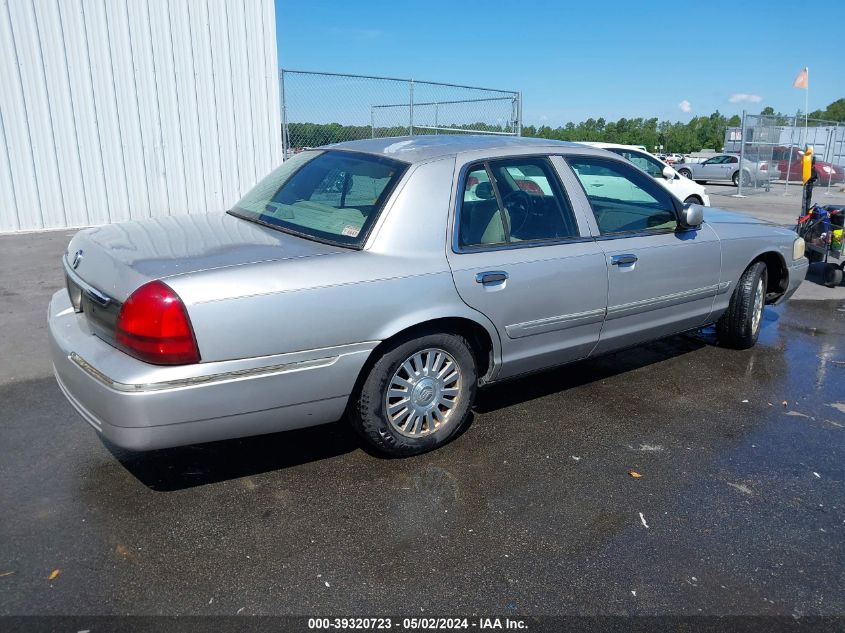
[280,69,522,156]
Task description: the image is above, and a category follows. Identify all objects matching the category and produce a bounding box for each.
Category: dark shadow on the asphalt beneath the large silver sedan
[112,328,715,492]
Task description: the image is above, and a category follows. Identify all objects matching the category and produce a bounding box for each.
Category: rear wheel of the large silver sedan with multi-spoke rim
[350,333,478,457]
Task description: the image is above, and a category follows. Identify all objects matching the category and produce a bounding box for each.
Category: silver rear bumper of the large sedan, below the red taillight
[48,290,377,451]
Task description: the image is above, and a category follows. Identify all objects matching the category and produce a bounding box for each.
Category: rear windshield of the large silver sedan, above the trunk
[229,151,406,248]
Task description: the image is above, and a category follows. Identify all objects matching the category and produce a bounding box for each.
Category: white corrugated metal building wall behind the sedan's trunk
[0,0,282,232]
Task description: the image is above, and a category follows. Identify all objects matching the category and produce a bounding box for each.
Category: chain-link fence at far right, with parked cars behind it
[725,113,845,195]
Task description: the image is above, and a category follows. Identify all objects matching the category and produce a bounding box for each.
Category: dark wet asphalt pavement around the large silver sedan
[0,234,845,617]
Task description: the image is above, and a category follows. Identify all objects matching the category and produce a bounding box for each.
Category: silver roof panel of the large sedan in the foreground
[321,134,583,163]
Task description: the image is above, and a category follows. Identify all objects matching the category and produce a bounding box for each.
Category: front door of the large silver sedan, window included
[566,155,721,354]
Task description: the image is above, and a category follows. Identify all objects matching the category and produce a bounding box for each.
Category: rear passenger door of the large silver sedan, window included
[447,156,607,378]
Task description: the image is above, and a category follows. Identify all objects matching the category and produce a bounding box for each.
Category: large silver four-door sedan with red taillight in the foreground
[49,136,807,455]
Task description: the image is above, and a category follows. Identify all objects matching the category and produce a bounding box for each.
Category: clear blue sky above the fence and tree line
[276,0,845,127]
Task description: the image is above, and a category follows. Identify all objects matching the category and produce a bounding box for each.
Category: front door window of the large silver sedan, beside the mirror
[566,156,678,235]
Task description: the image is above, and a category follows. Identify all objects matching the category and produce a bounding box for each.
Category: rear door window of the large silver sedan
[458,157,578,248]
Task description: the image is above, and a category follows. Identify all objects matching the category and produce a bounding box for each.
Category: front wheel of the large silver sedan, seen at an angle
[716,262,768,349]
